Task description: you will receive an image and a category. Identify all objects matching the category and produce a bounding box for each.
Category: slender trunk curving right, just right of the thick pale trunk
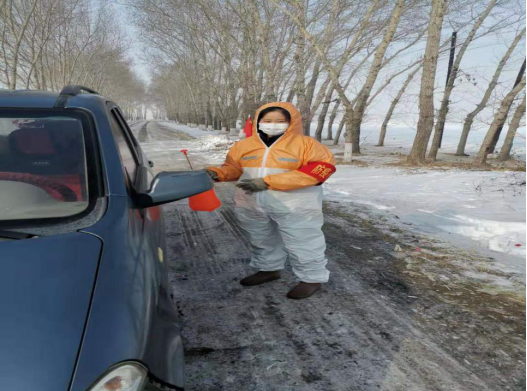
[428,0,496,160]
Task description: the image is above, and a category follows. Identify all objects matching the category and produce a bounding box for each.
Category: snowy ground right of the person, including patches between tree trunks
[324,128,526,295]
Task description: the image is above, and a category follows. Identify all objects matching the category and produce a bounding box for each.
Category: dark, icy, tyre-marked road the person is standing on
[131,122,525,391]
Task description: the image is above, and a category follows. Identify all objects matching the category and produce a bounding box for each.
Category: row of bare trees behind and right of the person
[131,0,525,164]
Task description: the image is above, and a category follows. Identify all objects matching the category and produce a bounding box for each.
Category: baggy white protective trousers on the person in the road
[235,189,329,283]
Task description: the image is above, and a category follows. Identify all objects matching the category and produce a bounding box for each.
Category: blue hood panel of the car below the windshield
[0,232,102,391]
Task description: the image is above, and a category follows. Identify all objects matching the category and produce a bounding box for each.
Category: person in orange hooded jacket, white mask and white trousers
[207,102,335,299]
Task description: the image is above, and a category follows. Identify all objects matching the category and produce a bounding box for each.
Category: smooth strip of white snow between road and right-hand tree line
[326,165,526,275]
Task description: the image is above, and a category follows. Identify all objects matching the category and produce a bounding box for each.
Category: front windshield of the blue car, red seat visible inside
[0,114,89,221]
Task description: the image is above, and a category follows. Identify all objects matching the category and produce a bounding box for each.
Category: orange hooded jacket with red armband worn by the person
[207,102,336,191]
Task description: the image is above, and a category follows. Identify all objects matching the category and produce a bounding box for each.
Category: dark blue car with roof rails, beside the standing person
[0,86,212,391]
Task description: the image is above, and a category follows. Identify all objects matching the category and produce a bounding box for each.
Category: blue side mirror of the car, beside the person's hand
[134,171,213,208]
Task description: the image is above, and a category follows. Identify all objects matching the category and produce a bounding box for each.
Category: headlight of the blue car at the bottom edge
[89,362,148,391]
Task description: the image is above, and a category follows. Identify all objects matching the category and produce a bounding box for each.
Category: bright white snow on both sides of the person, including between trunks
[156,122,527,286]
